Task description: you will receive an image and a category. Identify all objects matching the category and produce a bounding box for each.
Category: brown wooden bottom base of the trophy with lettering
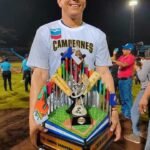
[37,127,113,150]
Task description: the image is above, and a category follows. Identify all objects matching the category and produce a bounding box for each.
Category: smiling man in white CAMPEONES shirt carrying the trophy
[28,0,121,148]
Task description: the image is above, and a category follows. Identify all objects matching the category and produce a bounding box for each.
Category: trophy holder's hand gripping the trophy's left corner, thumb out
[30,119,48,148]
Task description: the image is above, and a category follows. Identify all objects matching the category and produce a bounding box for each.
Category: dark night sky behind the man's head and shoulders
[0,0,150,49]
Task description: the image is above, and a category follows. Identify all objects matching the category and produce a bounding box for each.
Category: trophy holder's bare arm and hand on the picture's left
[29,68,48,146]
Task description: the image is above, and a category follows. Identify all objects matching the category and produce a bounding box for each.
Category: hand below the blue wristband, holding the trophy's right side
[110,111,121,142]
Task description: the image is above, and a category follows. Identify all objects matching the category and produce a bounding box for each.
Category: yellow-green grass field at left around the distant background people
[0,62,29,110]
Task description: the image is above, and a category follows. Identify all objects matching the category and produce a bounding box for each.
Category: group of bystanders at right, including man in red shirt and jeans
[111,43,150,150]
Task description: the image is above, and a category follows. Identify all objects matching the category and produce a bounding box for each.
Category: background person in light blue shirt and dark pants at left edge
[1,58,12,91]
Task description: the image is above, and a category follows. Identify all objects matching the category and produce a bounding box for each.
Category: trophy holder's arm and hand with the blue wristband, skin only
[96,67,121,141]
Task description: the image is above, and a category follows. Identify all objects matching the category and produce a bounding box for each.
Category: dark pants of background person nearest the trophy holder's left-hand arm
[23,70,31,91]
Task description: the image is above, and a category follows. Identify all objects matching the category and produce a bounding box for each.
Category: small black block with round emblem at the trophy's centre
[72,115,91,125]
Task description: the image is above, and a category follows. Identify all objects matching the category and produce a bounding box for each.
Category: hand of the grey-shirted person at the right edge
[139,97,148,114]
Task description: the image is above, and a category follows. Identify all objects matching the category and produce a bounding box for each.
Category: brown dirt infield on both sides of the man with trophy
[0,109,147,150]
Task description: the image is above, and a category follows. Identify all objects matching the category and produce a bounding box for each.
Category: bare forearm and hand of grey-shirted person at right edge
[139,83,150,114]
